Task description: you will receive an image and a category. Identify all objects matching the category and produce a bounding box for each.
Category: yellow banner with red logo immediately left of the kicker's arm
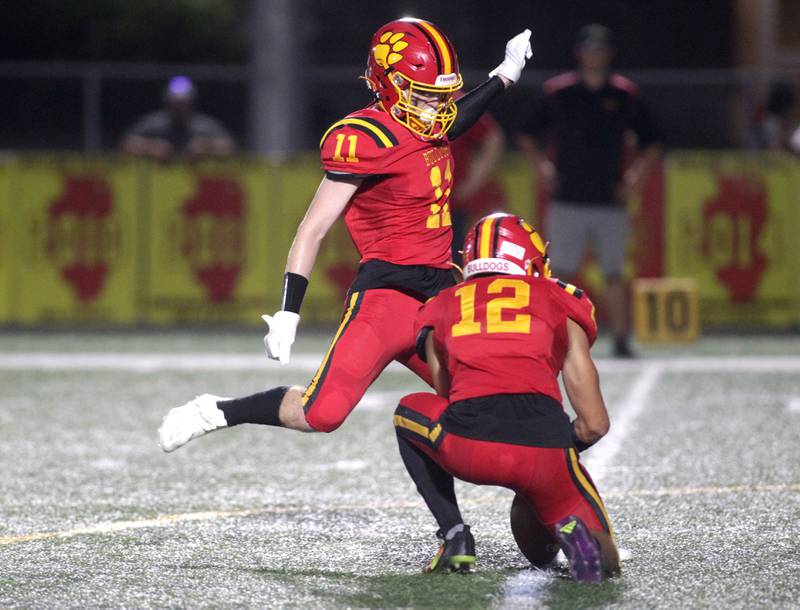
[142,160,278,324]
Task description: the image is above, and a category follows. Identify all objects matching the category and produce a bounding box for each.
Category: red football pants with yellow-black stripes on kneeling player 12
[394,393,612,533]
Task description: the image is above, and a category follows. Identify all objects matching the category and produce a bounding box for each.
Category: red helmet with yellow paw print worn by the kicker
[364,17,464,139]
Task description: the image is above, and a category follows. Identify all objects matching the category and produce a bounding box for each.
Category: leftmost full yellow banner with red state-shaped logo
[12,156,139,324]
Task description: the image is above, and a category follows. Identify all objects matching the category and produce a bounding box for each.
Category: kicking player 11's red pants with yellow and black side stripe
[303,288,431,432]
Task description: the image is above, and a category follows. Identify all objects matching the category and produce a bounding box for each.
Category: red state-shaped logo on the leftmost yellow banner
[45,176,118,302]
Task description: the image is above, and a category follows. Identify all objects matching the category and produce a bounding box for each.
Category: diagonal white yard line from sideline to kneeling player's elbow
[585,361,665,479]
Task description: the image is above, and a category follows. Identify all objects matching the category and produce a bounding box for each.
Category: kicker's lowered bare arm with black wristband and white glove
[261,177,361,364]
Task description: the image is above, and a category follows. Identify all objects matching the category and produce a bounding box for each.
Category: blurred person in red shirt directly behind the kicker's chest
[450,101,506,265]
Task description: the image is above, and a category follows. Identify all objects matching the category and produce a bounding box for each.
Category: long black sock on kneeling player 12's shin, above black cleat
[397,434,463,535]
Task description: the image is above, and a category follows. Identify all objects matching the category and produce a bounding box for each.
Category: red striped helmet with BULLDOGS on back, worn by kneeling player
[464,213,550,279]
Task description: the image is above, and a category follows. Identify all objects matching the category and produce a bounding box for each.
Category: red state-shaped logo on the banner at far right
[703,176,767,303]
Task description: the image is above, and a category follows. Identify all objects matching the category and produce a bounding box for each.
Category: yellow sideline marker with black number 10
[633,278,700,343]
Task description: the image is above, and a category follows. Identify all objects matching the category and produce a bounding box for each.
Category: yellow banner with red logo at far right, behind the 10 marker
[666,153,800,325]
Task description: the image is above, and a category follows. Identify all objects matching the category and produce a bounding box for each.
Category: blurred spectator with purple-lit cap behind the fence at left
[122,76,235,161]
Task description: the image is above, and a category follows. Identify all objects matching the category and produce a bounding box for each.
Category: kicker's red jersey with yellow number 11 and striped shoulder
[320,107,454,269]
